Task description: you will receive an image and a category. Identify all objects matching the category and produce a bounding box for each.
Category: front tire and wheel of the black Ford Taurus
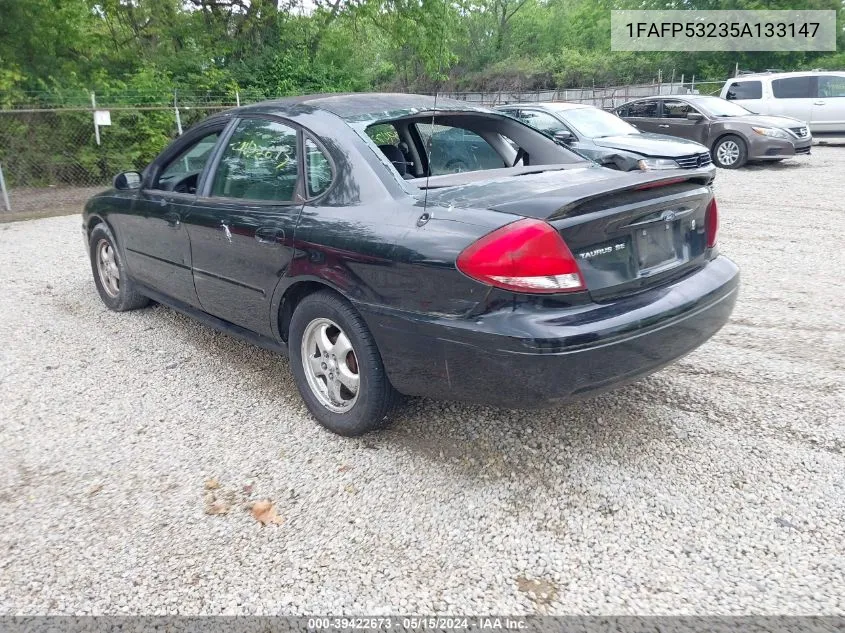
[88,223,150,312]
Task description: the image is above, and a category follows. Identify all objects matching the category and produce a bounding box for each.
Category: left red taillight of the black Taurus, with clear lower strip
[457,219,585,293]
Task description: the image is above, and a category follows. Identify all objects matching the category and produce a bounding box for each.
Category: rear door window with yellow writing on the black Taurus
[211,119,299,202]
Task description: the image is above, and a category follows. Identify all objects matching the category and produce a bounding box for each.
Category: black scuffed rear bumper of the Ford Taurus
[358,257,739,408]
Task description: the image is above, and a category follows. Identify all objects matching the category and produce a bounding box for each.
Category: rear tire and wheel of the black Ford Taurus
[288,290,398,437]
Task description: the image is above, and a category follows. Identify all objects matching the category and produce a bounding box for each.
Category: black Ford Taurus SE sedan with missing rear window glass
[83,94,739,435]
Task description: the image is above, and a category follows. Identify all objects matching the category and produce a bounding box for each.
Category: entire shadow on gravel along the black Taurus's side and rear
[85,286,671,479]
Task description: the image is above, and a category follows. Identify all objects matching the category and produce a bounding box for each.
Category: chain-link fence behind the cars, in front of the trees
[0,82,724,213]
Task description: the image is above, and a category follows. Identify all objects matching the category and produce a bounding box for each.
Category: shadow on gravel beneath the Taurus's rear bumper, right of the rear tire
[376,378,672,483]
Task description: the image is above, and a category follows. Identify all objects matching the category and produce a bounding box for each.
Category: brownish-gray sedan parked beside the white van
[616,95,813,169]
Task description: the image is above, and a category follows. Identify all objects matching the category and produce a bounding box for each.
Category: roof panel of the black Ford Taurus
[207,92,493,123]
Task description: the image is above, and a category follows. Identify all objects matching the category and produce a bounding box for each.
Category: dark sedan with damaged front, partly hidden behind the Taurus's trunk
[496,102,716,176]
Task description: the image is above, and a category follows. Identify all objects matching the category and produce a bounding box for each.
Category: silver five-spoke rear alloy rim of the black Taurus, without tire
[301,318,361,413]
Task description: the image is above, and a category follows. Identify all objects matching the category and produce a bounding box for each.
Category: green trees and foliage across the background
[0,0,845,185]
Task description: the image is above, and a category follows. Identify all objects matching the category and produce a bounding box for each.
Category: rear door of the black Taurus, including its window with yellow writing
[186,117,304,336]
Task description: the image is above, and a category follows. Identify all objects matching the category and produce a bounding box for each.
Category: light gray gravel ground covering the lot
[0,147,845,614]
